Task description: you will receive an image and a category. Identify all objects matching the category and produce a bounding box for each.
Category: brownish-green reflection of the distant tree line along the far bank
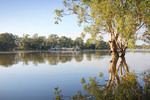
[0,51,109,67]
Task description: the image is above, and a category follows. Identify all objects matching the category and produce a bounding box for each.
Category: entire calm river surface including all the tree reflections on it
[0,51,150,100]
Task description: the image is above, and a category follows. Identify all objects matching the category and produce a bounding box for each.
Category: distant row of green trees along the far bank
[0,33,109,51]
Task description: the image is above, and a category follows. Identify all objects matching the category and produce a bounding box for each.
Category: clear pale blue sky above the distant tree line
[0,0,146,44]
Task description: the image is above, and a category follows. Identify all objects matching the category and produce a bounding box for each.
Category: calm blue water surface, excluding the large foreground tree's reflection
[0,51,150,100]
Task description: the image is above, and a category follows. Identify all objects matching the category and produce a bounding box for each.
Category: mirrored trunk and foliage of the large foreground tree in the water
[54,57,150,100]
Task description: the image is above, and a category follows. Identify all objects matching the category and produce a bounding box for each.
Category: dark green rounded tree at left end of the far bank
[0,33,18,51]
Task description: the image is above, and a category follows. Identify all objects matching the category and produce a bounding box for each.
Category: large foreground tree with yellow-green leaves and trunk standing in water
[55,0,150,57]
